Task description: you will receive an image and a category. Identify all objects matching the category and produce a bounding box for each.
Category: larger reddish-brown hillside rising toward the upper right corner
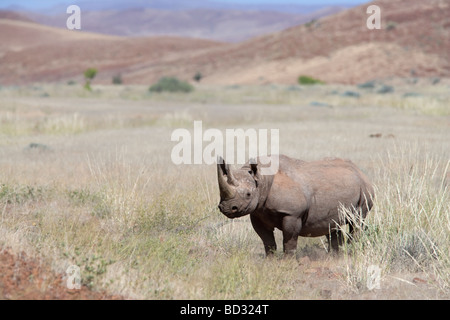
[135,0,450,84]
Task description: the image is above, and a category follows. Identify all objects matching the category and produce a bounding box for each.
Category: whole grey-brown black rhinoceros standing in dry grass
[217,155,374,255]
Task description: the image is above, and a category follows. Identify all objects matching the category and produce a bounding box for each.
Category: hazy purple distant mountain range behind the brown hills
[22,6,343,42]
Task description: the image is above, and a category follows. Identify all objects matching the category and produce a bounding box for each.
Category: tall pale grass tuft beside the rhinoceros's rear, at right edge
[343,151,450,290]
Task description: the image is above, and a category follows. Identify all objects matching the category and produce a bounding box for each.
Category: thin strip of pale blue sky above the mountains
[0,0,368,9]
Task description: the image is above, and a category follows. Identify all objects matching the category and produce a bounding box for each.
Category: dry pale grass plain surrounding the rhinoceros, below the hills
[0,85,450,299]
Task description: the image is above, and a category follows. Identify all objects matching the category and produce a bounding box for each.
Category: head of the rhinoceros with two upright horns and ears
[217,158,260,219]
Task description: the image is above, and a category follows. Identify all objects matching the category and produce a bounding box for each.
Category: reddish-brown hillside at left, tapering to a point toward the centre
[0,19,222,84]
